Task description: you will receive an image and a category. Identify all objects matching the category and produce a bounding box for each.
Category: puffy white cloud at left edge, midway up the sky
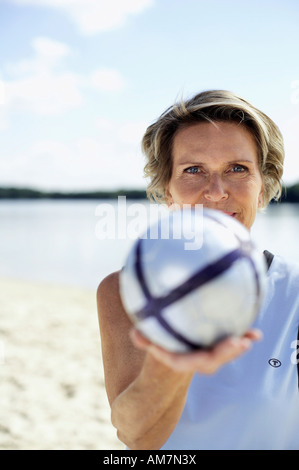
[2,37,83,115]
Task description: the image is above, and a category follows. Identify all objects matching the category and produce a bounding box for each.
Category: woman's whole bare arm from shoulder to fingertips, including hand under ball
[97,273,258,450]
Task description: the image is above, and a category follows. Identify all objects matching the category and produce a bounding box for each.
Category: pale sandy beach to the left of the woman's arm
[0,279,124,450]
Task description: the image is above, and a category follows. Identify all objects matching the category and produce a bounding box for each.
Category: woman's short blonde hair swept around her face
[142,90,284,207]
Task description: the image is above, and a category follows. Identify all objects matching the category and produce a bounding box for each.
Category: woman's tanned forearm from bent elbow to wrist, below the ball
[111,354,193,450]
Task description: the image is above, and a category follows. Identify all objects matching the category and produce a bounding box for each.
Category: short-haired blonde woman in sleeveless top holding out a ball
[97,90,299,450]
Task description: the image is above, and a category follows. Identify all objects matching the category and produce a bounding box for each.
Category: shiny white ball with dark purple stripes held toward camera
[120,208,266,352]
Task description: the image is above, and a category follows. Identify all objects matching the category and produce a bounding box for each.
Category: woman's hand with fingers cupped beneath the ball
[130,328,262,374]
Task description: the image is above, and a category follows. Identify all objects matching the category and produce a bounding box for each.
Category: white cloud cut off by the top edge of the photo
[8,0,154,35]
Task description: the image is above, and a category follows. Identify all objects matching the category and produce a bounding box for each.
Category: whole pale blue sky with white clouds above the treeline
[0,0,299,191]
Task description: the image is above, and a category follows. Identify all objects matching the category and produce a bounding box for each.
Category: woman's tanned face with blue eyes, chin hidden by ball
[166,122,263,229]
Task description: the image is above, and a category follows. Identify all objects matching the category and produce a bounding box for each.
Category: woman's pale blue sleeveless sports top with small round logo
[162,256,299,450]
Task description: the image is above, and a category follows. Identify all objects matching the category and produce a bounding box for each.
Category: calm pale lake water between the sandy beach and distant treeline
[0,200,299,288]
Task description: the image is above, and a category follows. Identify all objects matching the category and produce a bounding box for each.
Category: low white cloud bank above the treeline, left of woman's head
[0,117,146,190]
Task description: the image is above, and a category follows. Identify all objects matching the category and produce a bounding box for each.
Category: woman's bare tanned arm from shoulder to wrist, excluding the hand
[97,273,193,449]
